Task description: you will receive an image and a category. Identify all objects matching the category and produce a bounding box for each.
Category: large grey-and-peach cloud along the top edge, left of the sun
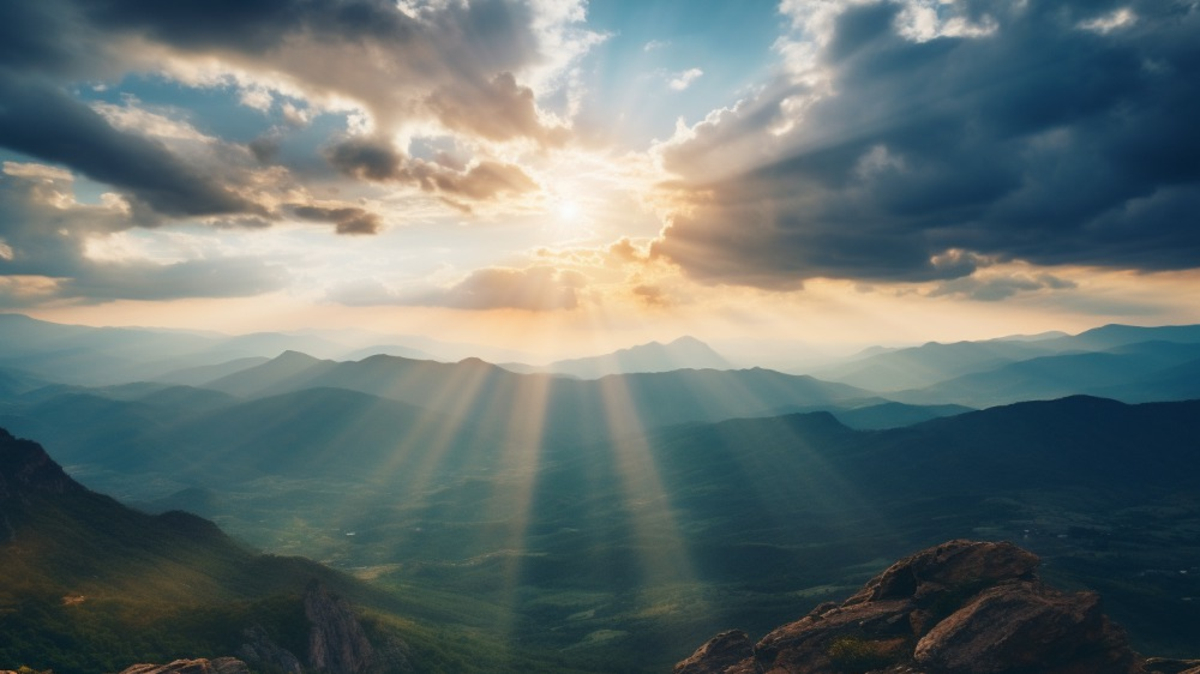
[25,0,596,140]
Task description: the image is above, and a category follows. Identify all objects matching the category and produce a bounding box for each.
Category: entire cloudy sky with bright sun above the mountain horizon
[0,0,1200,357]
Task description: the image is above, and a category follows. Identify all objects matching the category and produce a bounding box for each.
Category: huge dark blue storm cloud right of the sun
[653,0,1200,285]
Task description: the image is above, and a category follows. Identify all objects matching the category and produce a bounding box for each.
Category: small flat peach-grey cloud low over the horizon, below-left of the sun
[329,265,587,312]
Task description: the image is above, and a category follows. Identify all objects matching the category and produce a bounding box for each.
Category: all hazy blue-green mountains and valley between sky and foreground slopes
[0,318,1200,673]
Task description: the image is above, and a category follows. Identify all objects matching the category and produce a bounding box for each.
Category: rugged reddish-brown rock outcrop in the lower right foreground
[674,541,1161,674]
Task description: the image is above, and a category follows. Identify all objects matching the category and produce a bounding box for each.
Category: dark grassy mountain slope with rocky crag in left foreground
[0,429,614,674]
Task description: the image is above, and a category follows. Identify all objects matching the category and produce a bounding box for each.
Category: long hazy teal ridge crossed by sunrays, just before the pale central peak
[201,353,868,441]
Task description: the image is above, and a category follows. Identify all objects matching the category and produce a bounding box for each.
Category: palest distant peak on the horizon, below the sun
[500,337,732,379]
